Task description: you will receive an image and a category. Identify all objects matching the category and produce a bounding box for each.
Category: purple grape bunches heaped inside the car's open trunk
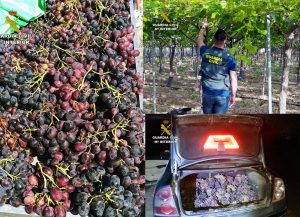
[194,174,258,208]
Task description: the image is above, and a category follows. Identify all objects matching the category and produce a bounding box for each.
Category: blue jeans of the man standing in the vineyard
[202,94,230,114]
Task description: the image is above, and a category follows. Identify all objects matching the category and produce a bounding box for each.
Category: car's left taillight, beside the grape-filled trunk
[153,186,179,216]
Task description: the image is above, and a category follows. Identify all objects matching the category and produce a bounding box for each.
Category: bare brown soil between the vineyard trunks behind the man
[144,57,300,114]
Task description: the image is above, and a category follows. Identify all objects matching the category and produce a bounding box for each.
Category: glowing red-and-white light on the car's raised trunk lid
[204,135,239,151]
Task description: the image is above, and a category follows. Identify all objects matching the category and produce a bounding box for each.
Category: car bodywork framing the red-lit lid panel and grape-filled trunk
[154,115,287,217]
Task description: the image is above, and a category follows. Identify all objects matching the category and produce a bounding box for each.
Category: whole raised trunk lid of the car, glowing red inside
[171,115,264,174]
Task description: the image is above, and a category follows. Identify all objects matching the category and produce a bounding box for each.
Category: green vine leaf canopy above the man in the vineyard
[144,0,300,62]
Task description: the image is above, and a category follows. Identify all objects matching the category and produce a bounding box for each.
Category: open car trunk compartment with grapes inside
[179,168,270,212]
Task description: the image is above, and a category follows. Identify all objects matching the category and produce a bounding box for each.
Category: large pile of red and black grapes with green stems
[0,0,145,217]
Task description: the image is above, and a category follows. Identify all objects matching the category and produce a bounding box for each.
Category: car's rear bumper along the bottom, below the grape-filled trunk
[154,200,287,217]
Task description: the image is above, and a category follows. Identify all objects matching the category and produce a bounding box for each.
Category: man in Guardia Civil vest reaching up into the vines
[197,18,237,114]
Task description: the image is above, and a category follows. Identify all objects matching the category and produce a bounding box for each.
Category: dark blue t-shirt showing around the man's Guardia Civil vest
[200,45,236,96]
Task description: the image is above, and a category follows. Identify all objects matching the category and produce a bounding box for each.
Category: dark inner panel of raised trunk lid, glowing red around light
[176,123,260,160]
